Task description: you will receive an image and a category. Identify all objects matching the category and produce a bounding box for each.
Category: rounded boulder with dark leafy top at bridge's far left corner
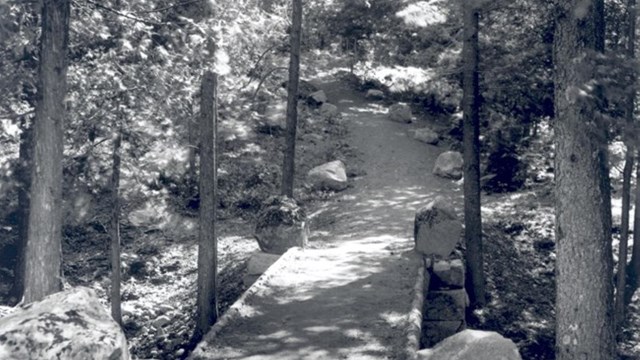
[254,196,309,255]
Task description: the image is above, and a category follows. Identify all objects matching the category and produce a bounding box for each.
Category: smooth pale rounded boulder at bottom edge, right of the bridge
[418,330,522,360]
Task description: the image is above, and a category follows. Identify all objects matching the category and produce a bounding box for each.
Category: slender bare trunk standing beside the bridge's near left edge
[194,71,218,341]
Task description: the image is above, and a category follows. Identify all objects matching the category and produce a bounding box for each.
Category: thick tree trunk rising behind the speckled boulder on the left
[24,0,69,303]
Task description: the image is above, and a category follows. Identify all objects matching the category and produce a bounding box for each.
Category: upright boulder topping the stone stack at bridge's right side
[413,197,462,259]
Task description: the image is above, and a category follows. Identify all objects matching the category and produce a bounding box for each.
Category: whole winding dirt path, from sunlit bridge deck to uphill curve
[194,74,461,360]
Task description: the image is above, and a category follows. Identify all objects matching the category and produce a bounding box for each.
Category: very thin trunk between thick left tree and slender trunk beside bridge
[109,130,122,325]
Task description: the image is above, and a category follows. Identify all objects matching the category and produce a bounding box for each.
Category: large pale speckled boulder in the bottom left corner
[0,287,129,360]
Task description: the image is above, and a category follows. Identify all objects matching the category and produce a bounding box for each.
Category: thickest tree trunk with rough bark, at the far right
[554,0,615,360]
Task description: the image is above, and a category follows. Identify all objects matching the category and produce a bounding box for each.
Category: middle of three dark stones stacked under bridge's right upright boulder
[424,289,469,321]
